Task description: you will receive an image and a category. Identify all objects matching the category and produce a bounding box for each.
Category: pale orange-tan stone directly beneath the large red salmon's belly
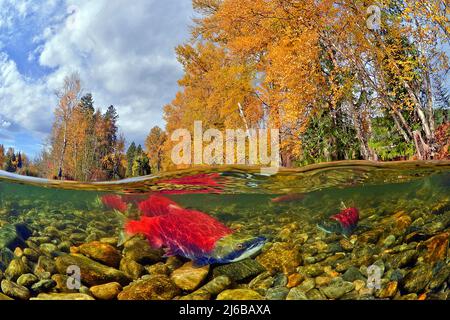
[170,262,209,291]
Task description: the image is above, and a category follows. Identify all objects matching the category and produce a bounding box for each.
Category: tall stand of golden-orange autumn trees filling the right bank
[165,0,450,165]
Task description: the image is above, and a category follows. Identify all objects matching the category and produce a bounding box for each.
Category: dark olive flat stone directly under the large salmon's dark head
[213,259,265,282]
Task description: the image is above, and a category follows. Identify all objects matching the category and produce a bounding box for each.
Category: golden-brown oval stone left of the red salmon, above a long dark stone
[78,241,122,268]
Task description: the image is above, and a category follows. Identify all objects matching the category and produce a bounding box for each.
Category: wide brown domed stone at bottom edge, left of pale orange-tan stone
[117,275,180,300]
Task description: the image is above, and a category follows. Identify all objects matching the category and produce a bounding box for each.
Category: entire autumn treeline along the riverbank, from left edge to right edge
[0,0,450,181]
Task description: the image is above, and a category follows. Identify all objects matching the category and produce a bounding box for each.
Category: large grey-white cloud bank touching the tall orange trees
[39,0,191,139]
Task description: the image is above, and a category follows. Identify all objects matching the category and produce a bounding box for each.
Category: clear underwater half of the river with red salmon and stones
[0,161,450,300]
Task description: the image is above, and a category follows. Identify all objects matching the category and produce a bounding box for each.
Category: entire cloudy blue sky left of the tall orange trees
[0,0,194,157]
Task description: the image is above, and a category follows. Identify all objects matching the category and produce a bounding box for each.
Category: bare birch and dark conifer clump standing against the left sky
[44,74,126,181]
